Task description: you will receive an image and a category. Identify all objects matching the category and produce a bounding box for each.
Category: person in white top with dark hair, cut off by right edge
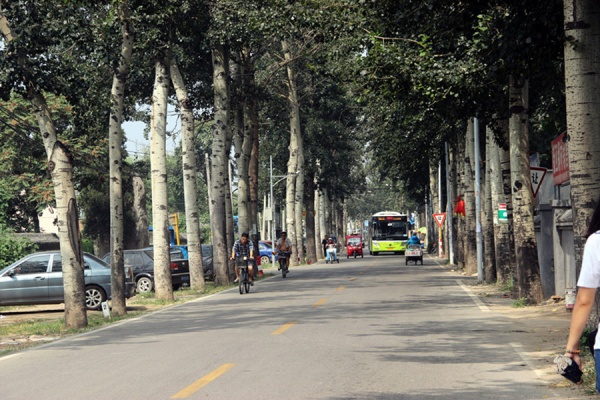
[564,200,600,393]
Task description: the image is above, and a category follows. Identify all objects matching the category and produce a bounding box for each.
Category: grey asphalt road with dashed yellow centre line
[0,255,576,400]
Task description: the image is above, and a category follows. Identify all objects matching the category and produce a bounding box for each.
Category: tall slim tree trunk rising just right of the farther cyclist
[281,41,303,266]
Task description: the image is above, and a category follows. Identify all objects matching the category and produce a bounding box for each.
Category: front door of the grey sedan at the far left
[0,254,50,305]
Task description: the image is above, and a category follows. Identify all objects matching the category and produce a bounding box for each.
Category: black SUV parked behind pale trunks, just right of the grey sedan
[102,247,190,293]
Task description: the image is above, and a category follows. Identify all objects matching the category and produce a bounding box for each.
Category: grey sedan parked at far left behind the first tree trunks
[0,251,135,310]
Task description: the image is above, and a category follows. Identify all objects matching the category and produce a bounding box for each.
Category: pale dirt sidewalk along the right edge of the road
[442,257,600,399]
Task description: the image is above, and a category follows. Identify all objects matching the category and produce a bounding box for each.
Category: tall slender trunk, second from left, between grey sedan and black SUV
[108,3,133,316]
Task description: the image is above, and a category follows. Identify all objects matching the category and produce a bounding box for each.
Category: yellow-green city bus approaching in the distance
[369,211,409,256]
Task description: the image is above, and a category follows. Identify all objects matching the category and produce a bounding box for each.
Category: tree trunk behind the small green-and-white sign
[490,121,514,284]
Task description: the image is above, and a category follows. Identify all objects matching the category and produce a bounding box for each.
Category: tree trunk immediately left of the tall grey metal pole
[463,119,479,275]
